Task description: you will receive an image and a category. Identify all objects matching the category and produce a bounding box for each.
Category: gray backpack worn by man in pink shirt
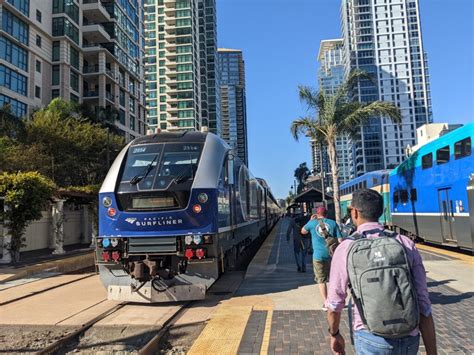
[347,230,420,338]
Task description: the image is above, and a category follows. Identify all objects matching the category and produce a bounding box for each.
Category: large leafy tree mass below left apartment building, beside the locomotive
[0,99,124,187]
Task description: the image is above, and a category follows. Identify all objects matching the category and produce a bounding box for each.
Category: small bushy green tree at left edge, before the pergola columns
[0,172,55,262]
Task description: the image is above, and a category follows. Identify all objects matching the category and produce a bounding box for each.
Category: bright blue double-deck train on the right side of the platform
[341,123,474,250]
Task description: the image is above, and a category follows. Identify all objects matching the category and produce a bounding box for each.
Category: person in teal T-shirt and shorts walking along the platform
[301,206,342,311]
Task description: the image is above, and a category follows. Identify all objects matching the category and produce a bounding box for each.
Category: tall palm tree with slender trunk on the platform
[291,70,401,223]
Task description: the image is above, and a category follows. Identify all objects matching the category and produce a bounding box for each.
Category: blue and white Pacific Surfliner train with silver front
[96,132,280,302]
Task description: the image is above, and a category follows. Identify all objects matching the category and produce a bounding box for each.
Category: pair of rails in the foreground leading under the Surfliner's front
[36,301,194,355]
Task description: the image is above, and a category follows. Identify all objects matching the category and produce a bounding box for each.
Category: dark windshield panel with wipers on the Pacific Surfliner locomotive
[117,143,202,210]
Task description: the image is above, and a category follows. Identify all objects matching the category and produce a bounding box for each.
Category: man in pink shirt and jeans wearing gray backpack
[327,189,437,355]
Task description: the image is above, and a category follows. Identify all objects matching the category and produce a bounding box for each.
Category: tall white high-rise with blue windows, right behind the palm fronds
[341,0,432,175]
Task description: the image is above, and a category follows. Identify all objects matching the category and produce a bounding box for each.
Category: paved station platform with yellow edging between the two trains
[189,219,474,354]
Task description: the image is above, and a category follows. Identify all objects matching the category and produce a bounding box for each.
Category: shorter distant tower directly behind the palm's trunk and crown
[311,39,354,184]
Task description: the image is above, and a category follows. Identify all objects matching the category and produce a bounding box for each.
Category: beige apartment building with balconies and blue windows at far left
[0,0,146,140]
